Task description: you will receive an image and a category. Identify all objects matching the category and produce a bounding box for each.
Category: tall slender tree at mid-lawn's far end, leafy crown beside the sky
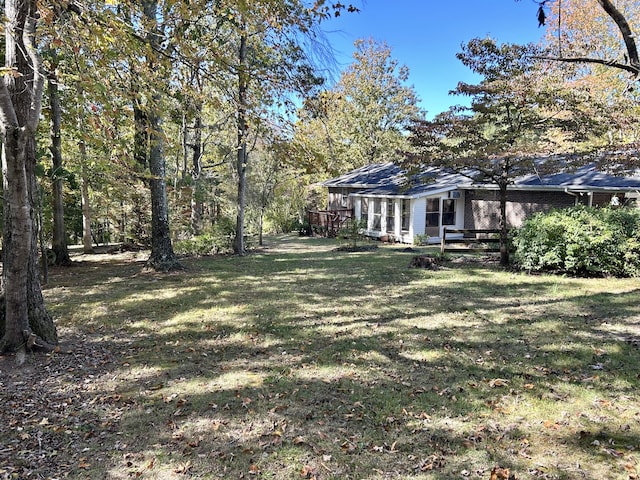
[218,0,350,255]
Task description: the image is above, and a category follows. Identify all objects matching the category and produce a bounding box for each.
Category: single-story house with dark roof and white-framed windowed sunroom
[322,163,640,243]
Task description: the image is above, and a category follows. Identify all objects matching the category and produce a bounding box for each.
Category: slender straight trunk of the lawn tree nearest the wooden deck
[233,27,249,255]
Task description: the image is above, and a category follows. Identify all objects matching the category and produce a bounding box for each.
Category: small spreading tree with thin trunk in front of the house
[407,38,597,265]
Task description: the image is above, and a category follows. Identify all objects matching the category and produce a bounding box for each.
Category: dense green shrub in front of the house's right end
[513,206,640,277]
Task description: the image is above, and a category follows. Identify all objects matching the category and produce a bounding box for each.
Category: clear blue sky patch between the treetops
[323,0,544,117]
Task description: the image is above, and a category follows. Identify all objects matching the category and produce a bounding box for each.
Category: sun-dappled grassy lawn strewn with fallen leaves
[0,237,640,480]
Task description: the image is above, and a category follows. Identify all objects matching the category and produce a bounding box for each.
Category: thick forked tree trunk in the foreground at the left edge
[0,0,57,352]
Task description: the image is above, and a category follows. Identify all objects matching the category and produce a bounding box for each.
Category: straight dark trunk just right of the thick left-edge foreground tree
[48,76,71,265]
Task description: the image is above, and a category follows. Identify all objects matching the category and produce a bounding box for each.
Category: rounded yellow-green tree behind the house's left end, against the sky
[296,39,424,175]
